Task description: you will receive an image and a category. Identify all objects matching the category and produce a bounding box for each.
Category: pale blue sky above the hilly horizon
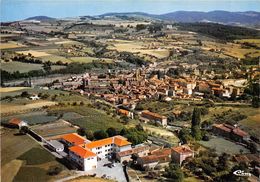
[0,0,260,22]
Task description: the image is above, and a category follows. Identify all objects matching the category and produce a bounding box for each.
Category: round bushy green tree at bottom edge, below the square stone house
[165,163,184,182]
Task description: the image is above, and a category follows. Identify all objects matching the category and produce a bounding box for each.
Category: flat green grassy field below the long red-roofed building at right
[199,137,249,155]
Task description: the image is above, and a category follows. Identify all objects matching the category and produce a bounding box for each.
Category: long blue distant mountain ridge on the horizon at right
[100,11,260,25]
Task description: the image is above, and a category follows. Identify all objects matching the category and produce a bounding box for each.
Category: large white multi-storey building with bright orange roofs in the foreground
[60,133,132,171]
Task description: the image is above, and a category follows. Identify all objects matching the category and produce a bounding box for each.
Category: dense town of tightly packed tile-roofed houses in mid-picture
[76,68,245,107]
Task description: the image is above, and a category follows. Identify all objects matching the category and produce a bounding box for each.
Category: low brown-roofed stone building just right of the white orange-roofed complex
[116,146,150,162]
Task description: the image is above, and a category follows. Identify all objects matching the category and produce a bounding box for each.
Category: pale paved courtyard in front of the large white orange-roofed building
[80,159,126,182]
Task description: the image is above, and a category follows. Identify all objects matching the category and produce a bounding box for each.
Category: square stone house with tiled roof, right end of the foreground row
[172,145,194,165]
